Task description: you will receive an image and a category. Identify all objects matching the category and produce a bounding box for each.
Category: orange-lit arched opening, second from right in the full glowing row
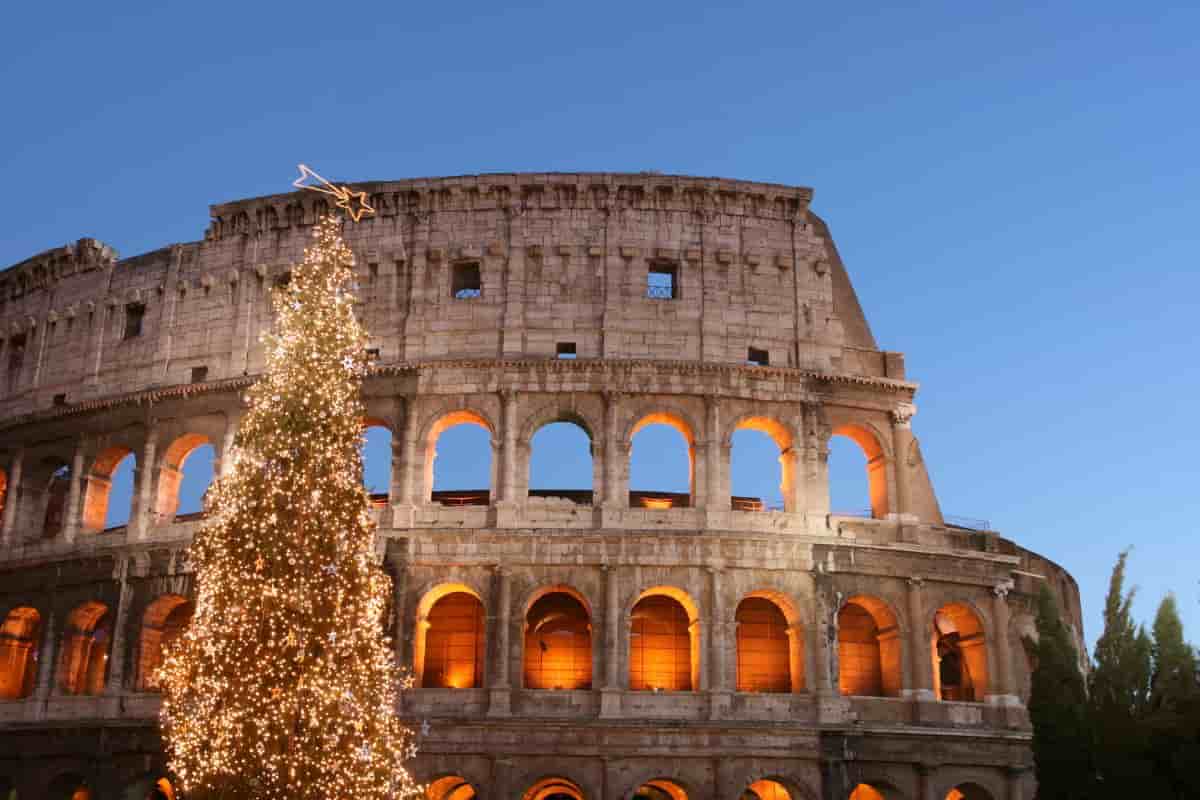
[838,595,901,697]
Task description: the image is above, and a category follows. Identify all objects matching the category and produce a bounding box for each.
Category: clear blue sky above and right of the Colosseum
[0,2,1200,652]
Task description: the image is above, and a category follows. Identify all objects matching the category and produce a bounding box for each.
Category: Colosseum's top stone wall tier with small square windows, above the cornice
[0,174,904,416]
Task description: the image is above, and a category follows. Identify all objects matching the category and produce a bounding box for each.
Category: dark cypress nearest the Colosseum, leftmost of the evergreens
[1030,587,1094,800]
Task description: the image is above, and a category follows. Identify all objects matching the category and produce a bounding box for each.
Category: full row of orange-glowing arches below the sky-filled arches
[0,584,989,702]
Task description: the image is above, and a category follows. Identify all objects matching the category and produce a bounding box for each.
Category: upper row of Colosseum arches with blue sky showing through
[0,400,888,539]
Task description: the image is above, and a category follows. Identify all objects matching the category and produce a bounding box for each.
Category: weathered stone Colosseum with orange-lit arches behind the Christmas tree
[0,174,1081,800]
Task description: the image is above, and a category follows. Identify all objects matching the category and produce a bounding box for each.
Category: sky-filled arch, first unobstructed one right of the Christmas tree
[425,411,496,505]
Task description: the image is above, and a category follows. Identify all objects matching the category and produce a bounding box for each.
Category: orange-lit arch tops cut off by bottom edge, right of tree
[425,775,994,800]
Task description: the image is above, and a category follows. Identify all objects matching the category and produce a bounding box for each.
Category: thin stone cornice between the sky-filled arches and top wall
[0,359,918,431]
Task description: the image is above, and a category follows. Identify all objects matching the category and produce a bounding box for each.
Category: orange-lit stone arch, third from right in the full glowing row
[733,589,805,692]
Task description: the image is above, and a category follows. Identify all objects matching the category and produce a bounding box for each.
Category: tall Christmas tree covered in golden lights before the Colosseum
[161,216,419,800]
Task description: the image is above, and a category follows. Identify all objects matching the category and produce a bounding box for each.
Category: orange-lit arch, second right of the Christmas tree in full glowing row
[524,588,592,690]
